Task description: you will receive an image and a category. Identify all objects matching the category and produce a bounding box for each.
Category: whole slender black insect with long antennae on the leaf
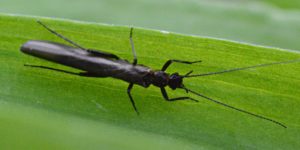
[21,21,299,128]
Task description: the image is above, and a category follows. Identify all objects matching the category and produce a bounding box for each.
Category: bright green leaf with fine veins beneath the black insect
[0,14,300,149]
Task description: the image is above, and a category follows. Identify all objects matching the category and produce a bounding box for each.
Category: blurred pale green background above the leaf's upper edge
[0,0,300,50]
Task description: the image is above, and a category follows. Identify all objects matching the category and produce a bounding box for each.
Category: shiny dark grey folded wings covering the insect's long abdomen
[21,41,150,87]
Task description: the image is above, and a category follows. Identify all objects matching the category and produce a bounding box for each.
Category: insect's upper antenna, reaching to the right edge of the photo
[184,59,300,78]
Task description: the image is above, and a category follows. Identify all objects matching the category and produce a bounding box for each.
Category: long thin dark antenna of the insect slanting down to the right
[181,87,287,128]
